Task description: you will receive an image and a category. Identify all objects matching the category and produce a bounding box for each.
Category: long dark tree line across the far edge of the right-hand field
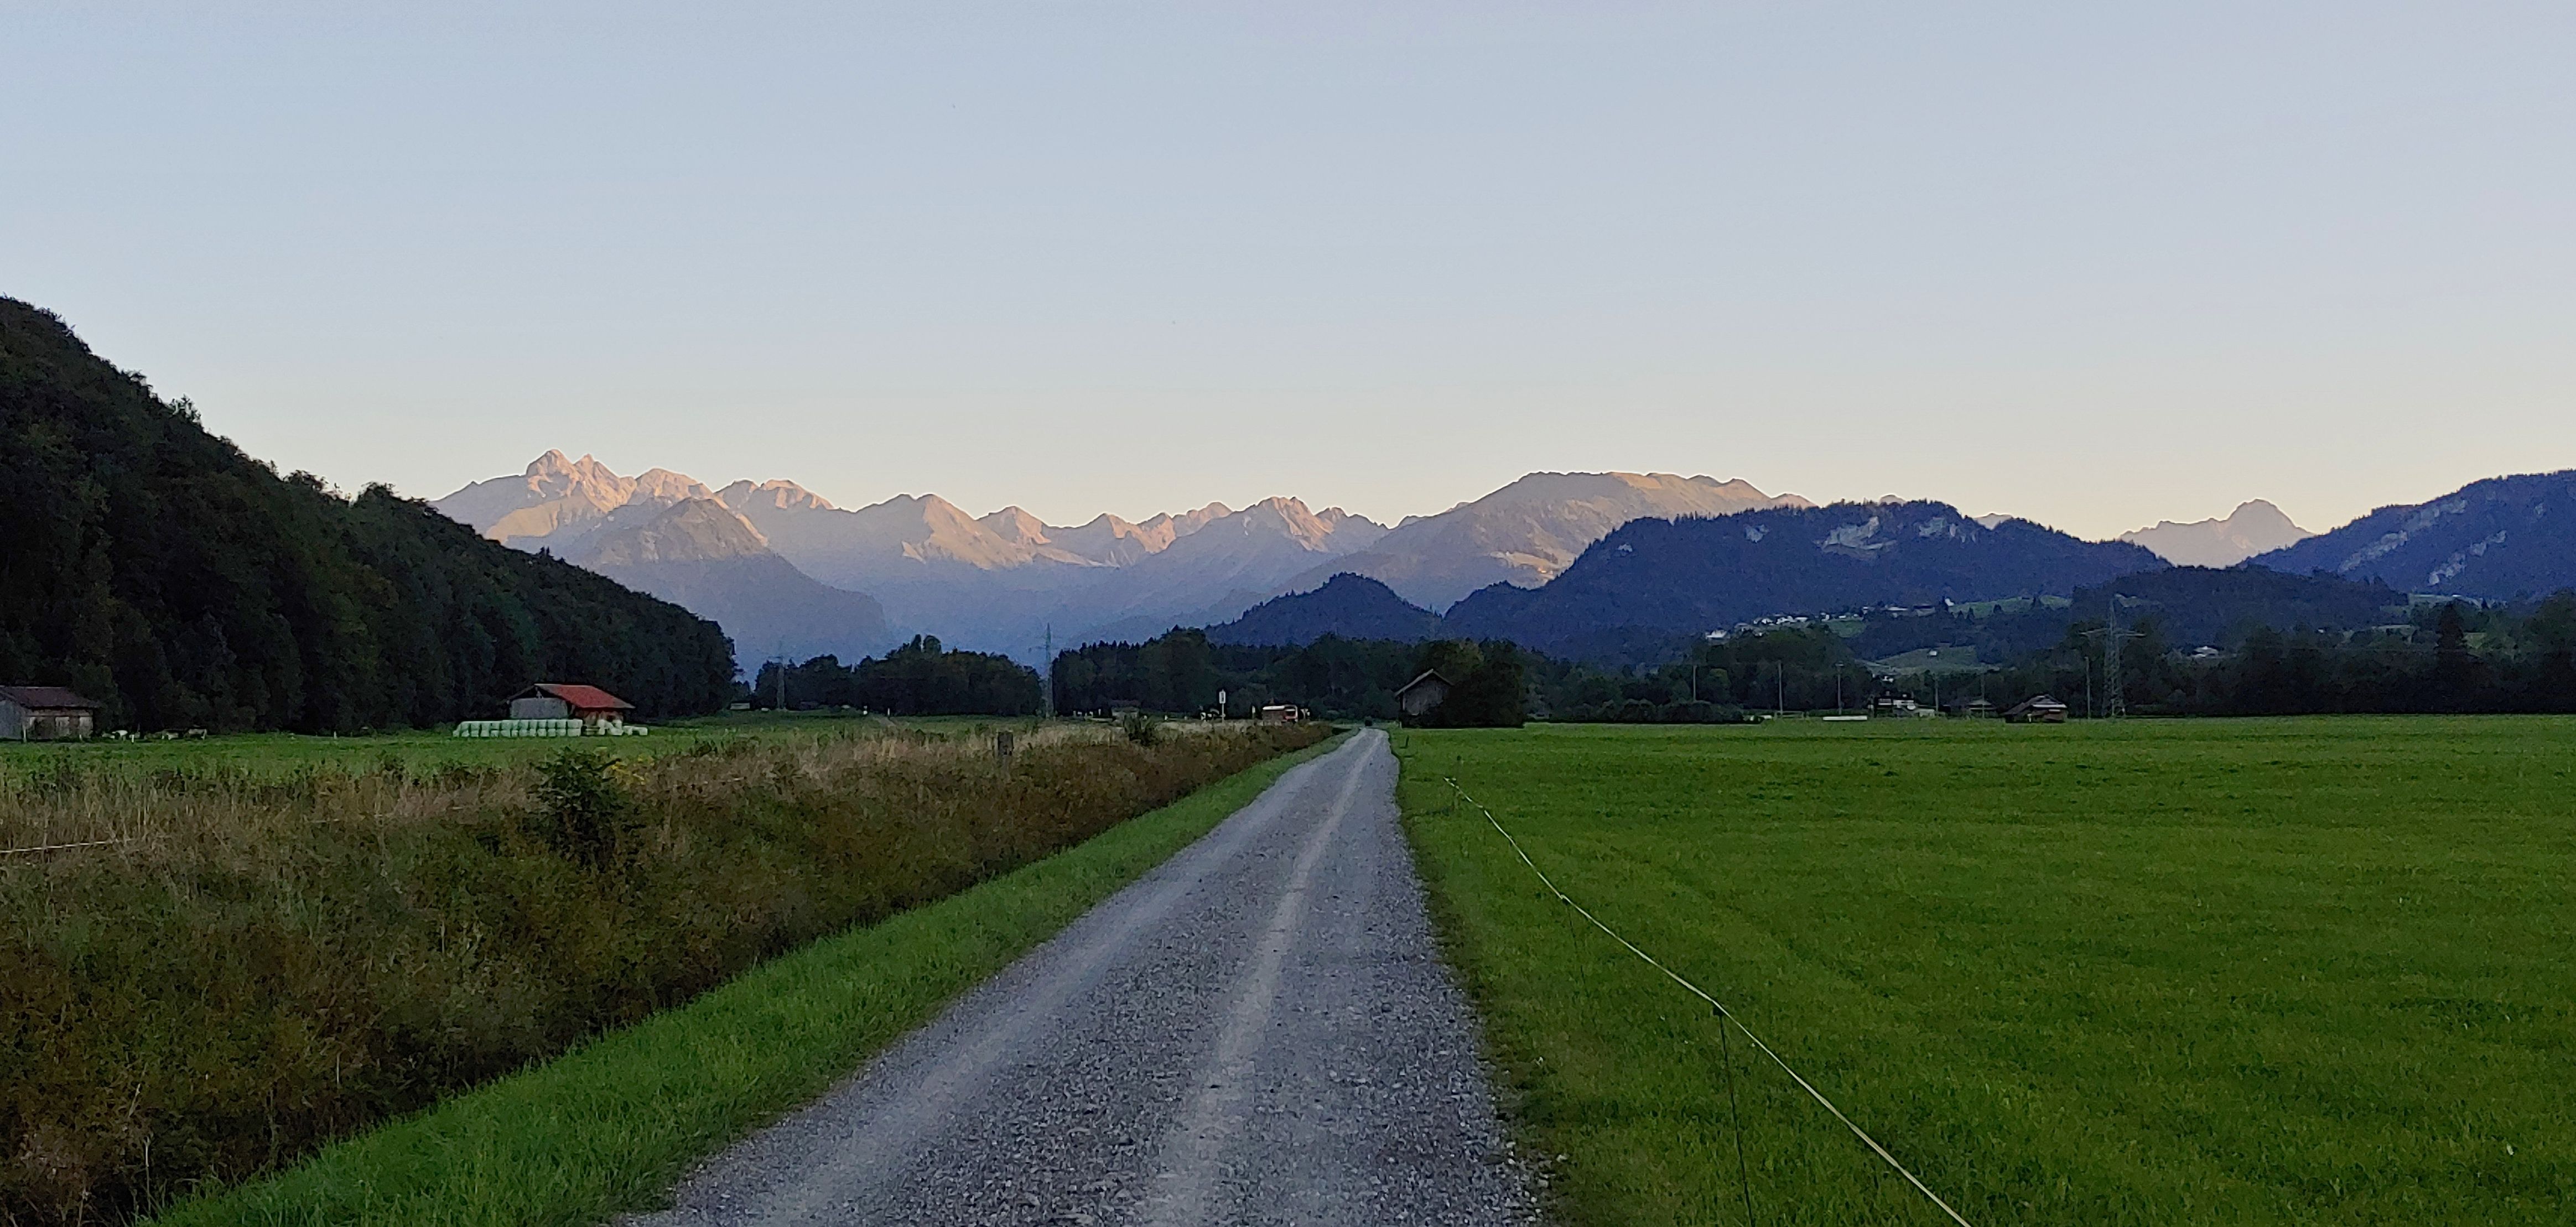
[1053,593,2576,724]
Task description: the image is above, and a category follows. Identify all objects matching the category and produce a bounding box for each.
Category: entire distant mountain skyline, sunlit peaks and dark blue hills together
[435,451,2576,660]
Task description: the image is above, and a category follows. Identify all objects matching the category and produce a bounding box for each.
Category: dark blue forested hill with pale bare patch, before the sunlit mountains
[1442,503,2164,657]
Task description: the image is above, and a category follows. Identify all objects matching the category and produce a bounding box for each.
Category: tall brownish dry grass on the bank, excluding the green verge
[0,727,1324,1224]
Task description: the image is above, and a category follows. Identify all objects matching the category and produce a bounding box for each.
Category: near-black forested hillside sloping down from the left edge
[0,299,731,732]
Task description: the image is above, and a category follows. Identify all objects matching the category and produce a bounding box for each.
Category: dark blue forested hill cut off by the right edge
[2254,469,2576,601]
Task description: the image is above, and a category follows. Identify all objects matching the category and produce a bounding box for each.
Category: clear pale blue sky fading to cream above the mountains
[0,3,2576,536]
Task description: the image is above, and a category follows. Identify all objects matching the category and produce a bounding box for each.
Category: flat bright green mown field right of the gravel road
[1396,716,2576,1227]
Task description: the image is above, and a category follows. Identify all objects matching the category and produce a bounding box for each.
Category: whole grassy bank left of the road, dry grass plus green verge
[0,730,1319,1222]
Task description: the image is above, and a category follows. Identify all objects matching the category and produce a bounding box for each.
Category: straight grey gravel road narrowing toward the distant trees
[631,730,1535,1227]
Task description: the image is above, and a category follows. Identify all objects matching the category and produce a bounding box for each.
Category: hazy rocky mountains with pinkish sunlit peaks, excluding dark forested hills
[435,451,1809,660]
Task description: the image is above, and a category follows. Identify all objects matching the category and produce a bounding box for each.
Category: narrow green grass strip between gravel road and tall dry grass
[152,735,1347,1227]
